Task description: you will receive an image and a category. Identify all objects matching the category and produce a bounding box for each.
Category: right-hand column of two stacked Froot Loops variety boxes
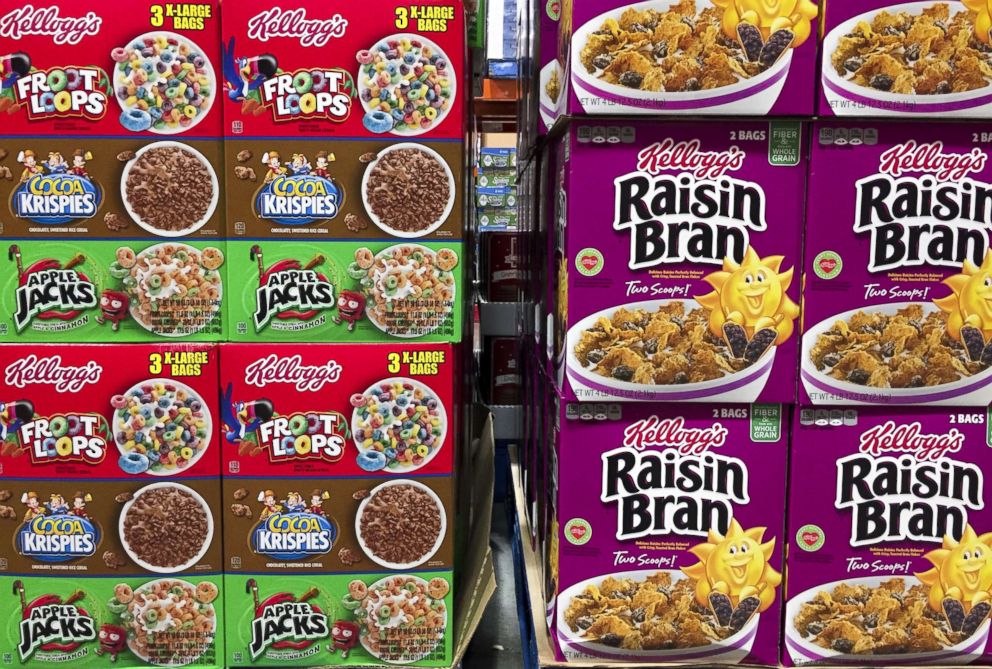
[220,0,468,667]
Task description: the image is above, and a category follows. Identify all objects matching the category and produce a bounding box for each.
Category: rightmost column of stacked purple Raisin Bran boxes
[783,0,992,666]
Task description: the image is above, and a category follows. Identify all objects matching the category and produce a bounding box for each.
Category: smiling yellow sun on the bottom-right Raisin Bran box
[916,525,992,632]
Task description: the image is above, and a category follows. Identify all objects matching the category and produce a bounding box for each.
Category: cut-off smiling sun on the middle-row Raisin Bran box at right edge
[933,250,992,362]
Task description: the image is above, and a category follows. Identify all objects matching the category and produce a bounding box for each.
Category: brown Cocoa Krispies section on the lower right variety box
[223,476,455,574]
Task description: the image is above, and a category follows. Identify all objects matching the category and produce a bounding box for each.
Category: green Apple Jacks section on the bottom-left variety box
[0,572,224,669]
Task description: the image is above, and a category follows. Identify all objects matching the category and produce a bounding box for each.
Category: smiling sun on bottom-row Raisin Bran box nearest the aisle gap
[682,519,782,629]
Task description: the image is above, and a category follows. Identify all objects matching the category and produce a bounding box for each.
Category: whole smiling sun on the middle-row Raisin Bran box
[696,247,799,362]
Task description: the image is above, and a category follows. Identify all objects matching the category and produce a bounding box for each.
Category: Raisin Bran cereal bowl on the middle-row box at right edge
[800,302,992,405]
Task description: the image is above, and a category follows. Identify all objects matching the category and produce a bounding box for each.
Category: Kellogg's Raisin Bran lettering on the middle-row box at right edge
[854,140,992,272]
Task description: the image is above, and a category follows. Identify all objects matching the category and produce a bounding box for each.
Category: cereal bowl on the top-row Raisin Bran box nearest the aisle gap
[569,0,796,114]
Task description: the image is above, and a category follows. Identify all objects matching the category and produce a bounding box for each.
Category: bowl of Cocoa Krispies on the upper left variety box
[121,141,220,237]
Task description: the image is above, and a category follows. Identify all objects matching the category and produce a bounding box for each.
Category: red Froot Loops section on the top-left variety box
[0,0,225,137]
